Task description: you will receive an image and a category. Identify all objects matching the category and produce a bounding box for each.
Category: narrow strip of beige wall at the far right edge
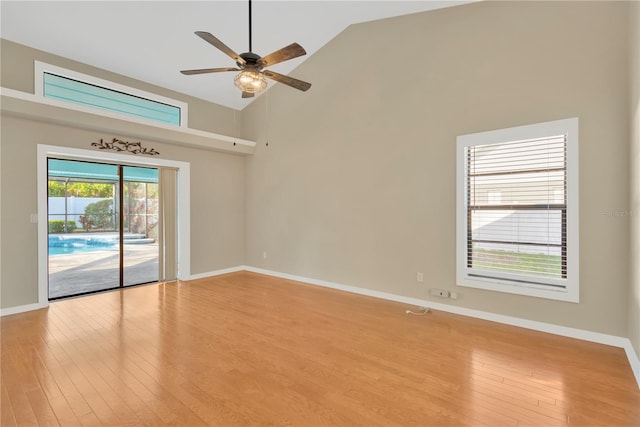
[629,1,640,355]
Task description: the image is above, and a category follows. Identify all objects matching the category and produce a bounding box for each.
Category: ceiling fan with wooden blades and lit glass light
[180,0,311,98]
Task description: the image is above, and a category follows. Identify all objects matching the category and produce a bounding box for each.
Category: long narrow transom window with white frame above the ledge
[35,61,187,127]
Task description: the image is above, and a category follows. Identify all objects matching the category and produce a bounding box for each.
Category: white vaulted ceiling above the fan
[0,0,467,110]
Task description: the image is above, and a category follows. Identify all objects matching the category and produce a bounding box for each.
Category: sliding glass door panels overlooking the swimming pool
[47,159,159,299]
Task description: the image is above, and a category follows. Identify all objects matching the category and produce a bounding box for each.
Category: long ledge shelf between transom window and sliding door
[0,87,256,155]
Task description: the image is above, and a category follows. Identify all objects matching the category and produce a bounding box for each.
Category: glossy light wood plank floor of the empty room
[0,272,640,426]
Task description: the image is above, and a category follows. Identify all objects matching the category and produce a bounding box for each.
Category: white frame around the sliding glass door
[37,144,191,308]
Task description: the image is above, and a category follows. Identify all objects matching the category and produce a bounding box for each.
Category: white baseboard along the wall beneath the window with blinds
[243,266,640,388]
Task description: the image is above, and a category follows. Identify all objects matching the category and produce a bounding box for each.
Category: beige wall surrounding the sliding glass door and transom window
[0,41,244,308]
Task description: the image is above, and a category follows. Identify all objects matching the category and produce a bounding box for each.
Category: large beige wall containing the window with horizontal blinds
[243,2,630,336]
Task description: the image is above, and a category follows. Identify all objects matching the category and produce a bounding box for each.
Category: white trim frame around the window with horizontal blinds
[456,117,580,303]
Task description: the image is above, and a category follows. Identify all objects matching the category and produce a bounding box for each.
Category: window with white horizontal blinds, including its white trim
[457,119,578,301]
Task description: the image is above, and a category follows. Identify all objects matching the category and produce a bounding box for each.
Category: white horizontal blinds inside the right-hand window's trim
[465,135,567,286]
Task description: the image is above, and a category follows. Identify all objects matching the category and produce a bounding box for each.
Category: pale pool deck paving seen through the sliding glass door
[49,239,158,298]
